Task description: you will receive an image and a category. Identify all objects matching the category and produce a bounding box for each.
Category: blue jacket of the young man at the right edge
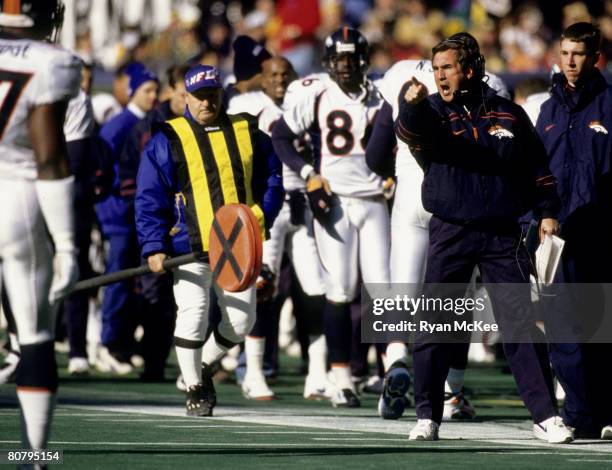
[536,70,612,222]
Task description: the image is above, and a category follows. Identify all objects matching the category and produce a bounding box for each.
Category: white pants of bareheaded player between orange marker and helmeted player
[263,202,325,296]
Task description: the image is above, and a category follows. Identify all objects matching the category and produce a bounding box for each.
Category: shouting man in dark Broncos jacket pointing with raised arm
[396,35,572,443]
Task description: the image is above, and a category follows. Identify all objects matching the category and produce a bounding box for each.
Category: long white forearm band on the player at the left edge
[35,176,75,253]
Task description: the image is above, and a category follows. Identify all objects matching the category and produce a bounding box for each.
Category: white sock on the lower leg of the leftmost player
[17,389,55,449]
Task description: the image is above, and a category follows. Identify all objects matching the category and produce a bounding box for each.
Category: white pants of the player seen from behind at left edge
[0,179,55,346]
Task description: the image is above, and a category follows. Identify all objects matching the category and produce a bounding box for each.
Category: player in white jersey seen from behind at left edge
[0,0,81,456]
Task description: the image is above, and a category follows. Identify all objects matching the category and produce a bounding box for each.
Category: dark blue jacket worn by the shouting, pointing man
[396,83,558,223]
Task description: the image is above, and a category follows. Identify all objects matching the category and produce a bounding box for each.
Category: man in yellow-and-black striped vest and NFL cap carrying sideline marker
[136,65,283,416]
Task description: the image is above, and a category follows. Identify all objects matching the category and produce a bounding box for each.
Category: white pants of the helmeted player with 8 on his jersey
[314,196,390,303]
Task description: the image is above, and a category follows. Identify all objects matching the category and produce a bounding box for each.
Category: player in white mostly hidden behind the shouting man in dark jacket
[366,49,510,419]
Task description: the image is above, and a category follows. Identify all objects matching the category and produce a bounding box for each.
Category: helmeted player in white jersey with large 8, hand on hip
[272,27,389,407]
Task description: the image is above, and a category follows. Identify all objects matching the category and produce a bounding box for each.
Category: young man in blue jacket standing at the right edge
[537,23,612,439]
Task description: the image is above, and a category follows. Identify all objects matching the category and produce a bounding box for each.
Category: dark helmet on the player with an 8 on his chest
[323,26,370,90]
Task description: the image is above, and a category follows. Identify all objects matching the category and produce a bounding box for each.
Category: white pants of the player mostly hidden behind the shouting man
[391,169,431,288]
